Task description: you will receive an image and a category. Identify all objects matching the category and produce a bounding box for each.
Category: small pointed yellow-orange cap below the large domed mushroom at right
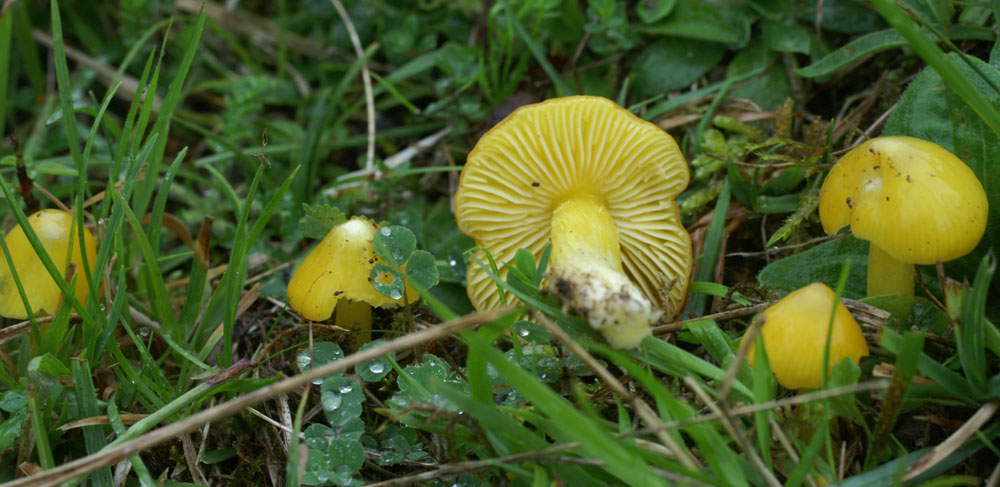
[747,282,868,389]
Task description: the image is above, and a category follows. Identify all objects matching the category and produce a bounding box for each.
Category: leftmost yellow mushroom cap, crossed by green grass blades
[0,210,97,320]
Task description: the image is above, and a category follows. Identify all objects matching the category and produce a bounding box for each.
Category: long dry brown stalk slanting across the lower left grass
[0,306,515,487]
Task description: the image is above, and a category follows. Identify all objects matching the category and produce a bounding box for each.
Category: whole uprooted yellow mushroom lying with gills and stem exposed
[455,96,691,348]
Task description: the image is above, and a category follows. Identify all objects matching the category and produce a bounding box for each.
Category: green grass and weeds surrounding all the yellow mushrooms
[0,0,1000,487]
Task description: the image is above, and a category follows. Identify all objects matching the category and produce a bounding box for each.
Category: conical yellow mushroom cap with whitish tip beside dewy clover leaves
[288,216,418,321]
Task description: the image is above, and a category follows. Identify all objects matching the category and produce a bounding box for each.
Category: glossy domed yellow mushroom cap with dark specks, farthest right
[819,136,989,264]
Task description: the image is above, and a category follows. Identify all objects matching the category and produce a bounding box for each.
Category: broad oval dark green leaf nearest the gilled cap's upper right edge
[632,37,726,98]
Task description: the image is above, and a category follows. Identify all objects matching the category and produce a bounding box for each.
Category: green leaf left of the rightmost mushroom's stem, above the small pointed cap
[757,235,868,299]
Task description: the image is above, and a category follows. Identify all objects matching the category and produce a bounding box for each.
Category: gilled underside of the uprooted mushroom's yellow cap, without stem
[455,96,691,315]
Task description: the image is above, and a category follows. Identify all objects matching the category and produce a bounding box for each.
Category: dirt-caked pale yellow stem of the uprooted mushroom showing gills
[547,195,663,348]
